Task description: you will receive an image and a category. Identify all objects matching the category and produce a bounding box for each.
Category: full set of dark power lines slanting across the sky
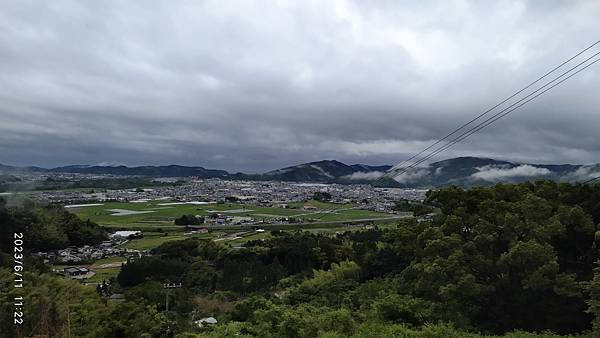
[386,41,600,180]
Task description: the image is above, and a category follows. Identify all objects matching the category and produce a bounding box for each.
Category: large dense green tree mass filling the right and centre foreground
[113,182,600,336]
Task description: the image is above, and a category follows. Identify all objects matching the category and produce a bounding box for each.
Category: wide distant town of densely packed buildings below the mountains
[29,178,426,212]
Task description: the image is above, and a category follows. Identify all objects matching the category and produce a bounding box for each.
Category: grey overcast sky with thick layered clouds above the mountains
[0,0,600,171]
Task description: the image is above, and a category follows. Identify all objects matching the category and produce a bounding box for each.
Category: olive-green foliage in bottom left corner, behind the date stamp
[0,269,177,338]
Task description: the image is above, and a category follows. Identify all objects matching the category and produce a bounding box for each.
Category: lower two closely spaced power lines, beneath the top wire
[394,52,600,176]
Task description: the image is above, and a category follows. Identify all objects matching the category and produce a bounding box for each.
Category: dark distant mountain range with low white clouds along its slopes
[0,157,600,188]
